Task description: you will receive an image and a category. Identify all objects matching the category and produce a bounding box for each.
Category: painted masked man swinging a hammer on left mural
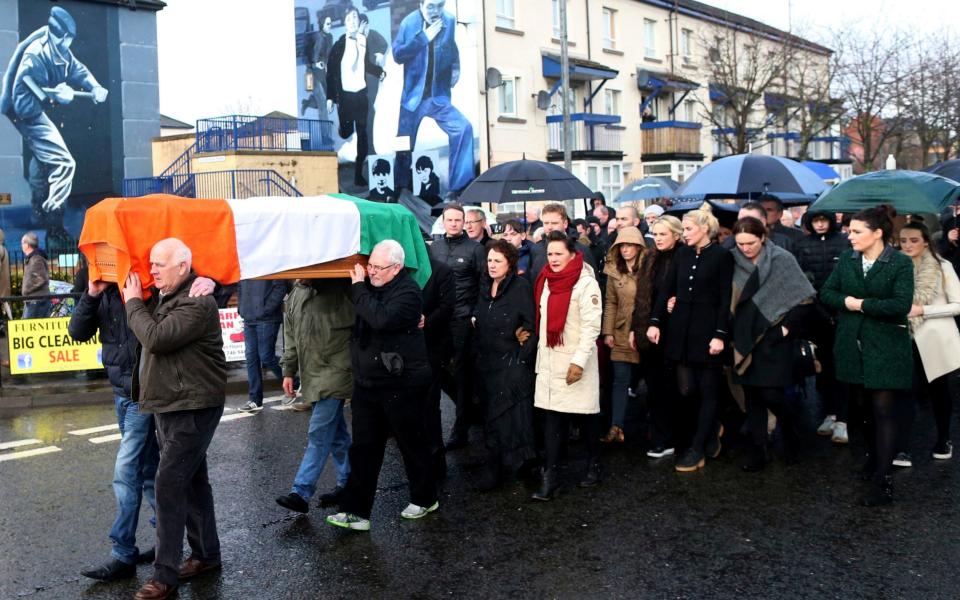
[0,6,107,237]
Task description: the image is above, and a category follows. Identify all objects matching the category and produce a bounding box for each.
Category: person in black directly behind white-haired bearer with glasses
[420,258,457,479]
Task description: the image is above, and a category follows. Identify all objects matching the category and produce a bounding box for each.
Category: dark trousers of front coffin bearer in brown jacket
[153,406,223,585]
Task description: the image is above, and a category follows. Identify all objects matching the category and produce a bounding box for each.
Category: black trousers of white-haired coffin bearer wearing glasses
[340,385,437,519]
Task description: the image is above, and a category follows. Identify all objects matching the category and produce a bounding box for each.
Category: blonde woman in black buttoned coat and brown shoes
[647,202,733,472]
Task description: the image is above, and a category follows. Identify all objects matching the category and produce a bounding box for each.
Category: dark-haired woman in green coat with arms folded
[820,205,913,506]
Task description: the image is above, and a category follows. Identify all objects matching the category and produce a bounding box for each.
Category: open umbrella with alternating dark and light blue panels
[673,154,827,199]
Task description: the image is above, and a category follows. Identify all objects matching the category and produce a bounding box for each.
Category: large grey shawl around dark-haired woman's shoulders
[730,242,817,375]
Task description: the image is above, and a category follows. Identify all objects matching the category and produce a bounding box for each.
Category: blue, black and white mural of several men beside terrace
[294,0,480,207]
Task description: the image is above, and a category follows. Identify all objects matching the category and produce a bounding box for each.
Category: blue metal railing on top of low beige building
[196,115,334,152]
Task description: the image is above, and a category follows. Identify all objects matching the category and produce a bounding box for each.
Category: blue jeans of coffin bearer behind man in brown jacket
[110,388,160,564]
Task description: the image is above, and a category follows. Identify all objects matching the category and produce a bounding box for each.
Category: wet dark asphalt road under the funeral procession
[0,396,960,599]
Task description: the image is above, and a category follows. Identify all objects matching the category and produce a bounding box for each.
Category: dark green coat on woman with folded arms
[820,247,913,390]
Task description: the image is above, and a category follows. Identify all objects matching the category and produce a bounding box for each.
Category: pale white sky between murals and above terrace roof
[157,0,960,123]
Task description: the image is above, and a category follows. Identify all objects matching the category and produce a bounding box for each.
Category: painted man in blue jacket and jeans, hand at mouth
[393,0,475,192]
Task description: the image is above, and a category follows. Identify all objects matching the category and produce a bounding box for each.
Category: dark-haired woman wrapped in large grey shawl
[730,217,817,472]
